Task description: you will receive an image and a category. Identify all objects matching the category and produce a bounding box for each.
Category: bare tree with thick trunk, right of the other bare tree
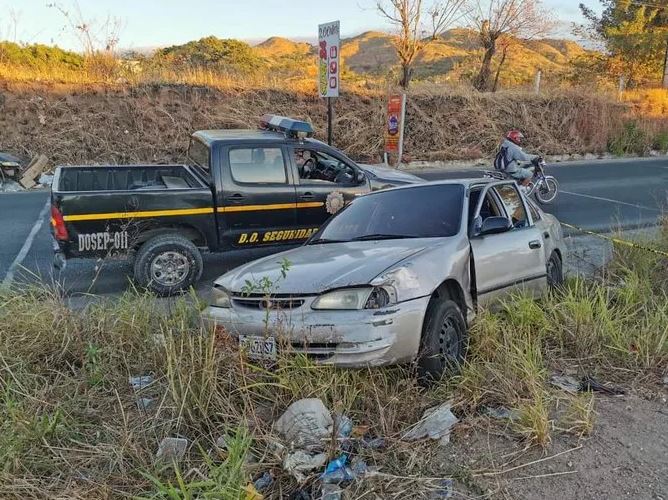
[469,0,552,91]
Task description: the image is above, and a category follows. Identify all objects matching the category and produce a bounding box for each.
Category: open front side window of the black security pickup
[292,148,356,186]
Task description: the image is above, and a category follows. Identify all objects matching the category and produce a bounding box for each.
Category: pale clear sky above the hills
[0,0,598,50]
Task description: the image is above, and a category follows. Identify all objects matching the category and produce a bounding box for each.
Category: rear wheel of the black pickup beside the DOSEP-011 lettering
[134,234,203,296]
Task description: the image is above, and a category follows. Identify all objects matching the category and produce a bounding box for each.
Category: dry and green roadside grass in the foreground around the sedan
[0,224,668,498]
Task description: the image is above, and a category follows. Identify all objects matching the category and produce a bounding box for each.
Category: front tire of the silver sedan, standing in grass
[417,298,468,385]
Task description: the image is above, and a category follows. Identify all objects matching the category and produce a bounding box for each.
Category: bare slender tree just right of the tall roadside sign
[376,0,467,89]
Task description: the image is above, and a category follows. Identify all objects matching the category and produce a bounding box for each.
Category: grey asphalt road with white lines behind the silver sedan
[0,158,668,294]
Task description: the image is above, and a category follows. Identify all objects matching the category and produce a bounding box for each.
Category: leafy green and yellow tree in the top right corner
[580,0,668,86]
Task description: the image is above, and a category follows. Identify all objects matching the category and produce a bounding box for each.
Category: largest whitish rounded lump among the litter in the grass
[275,398,334,450]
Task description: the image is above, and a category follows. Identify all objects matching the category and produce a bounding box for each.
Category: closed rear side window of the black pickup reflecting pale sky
[229,148,287,184]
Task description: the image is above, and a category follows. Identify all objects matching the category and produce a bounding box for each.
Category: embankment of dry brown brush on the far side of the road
[0,83,624,164]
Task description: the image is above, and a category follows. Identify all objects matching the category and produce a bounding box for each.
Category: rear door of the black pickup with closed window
[217,144,296,248]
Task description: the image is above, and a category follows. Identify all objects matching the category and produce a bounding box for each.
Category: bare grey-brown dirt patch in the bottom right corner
[444,393,668,500]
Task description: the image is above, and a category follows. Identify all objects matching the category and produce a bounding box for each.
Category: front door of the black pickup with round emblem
[288,144,368,227]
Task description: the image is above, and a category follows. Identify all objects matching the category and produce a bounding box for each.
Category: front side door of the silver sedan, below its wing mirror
[470,182,547,306]
